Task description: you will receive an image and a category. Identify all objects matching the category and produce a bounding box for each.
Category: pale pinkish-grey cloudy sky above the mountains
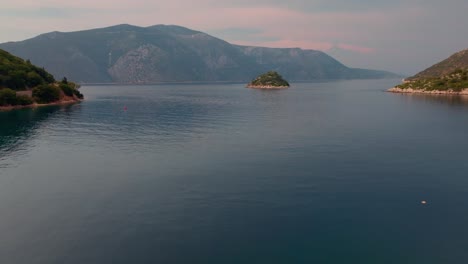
[0,0,468,75]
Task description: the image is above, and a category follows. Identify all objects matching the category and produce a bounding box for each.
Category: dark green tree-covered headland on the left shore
[0,49,83,110]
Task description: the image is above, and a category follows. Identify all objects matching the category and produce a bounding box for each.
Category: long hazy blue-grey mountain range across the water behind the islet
[0,25,396,83]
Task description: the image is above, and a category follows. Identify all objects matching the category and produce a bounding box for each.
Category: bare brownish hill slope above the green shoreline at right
[408,49,468,80]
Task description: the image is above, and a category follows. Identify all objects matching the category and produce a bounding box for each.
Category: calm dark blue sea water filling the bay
[0,80,468,264]
